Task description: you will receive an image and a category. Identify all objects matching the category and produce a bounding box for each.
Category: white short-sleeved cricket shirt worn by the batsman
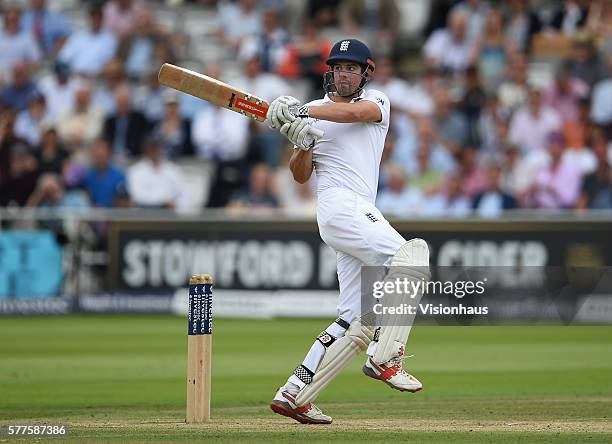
[307,89,390,203]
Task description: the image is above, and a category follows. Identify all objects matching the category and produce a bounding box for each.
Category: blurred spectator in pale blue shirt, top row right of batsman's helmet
[423,11,473,73]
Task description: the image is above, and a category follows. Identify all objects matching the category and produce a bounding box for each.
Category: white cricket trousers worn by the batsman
[317,188,406,323]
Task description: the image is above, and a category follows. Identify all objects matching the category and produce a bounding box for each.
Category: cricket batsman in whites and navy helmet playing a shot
[267,39,429,424]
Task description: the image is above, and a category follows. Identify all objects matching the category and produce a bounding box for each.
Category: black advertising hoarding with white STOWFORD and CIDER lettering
[109,219,612,292]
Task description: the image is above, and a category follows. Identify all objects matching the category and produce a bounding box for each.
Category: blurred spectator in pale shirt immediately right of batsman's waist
[376,163,425,217]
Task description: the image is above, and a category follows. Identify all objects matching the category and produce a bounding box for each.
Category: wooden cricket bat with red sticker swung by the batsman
[158,63,324,146]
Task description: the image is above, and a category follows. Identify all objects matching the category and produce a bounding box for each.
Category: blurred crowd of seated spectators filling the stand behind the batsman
[0,0,612,217]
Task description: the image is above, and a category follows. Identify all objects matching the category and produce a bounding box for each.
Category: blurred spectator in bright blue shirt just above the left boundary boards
[84,139,126,208]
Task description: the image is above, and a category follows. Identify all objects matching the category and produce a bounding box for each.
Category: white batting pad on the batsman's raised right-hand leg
[372,238,431,364]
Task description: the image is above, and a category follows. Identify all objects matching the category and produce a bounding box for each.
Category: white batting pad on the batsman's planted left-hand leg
[296,318,374,406]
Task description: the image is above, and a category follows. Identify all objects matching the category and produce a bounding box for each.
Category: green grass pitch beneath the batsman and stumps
[0,315,612,443]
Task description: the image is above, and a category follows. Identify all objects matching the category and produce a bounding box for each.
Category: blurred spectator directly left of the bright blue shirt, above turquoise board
[27,174,89,209]
